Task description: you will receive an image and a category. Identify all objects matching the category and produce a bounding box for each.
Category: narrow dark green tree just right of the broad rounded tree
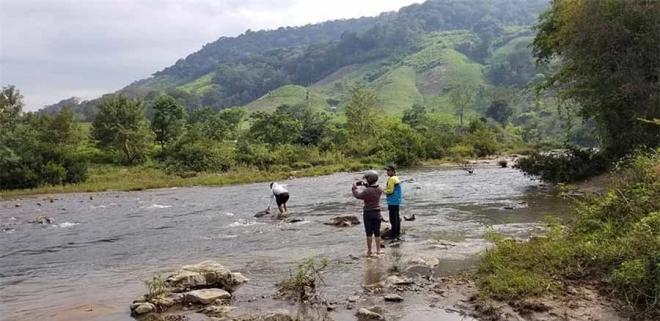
[151,95,186,150]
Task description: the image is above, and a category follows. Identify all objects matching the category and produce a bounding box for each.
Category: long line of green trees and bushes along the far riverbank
[0,82,519,189]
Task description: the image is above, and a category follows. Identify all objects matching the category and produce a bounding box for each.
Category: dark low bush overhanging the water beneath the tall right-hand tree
[514,146,609,183]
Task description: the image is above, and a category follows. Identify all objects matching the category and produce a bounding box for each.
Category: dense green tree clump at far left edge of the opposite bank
[0,86,87,189]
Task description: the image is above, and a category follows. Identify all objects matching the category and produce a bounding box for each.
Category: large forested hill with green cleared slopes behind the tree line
[38,0,548,119]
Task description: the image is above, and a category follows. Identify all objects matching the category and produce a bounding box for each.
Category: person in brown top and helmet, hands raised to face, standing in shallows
[351,171,383,257]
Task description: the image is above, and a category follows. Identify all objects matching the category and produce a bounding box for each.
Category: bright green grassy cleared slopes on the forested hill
[248,31,488,116]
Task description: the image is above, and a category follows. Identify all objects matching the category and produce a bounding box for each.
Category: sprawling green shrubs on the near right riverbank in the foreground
[478,150,660,315]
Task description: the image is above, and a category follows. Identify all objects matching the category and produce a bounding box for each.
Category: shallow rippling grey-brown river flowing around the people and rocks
[0,164,569,321]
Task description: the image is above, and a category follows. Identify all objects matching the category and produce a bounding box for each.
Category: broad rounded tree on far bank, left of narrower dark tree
[91,95,153,164]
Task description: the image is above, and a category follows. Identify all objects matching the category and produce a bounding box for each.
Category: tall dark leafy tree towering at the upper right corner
[533,0,660,156]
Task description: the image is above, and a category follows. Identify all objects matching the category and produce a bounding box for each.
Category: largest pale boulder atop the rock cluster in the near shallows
[165,261,248,293]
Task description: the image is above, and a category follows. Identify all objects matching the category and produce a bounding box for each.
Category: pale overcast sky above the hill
[0,0,422,110]
